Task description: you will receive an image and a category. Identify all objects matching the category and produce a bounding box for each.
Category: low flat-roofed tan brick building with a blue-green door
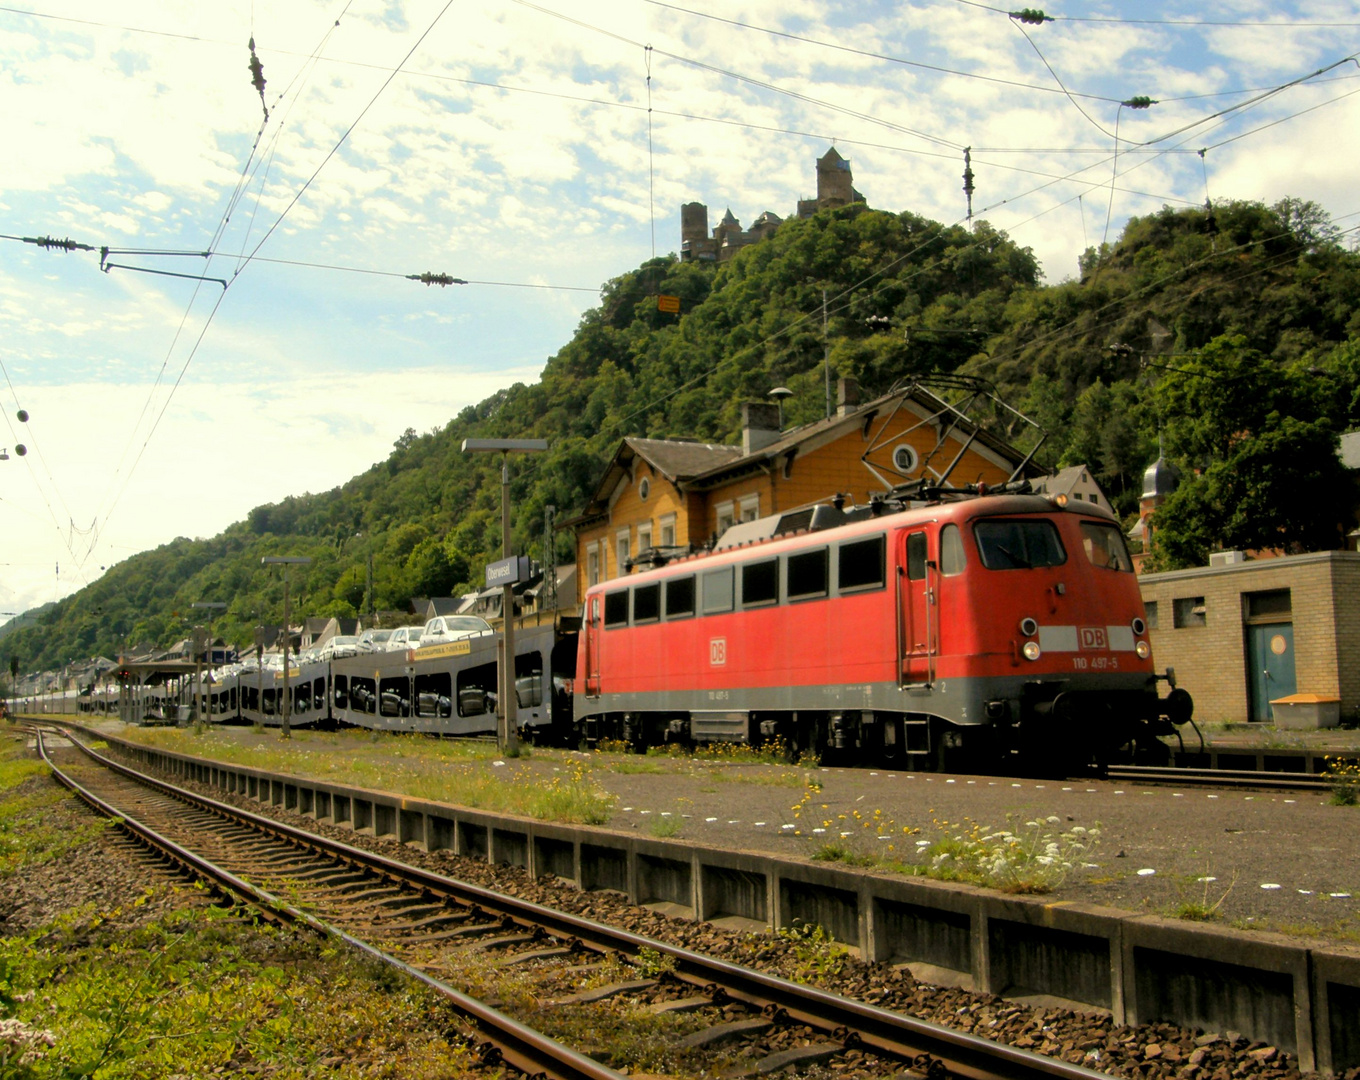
[1138,551,1360,724]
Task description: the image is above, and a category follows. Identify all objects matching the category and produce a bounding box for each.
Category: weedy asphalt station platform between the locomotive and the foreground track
[47,721,1360,947]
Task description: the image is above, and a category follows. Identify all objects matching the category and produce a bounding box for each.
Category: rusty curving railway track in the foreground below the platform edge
[39,718,1102,1080]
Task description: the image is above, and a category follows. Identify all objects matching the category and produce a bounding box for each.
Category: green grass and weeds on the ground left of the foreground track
[0,739,484,1080]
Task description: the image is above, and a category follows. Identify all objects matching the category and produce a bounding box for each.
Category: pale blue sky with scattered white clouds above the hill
[0,0,1360,620]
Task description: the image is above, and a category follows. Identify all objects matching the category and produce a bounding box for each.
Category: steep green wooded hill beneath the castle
[10,201,1360,671]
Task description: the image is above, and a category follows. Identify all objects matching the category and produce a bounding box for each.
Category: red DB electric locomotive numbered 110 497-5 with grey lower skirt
[574,486,1193,771]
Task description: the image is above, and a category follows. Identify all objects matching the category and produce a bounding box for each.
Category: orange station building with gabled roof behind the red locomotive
[560,379,1024,598]
